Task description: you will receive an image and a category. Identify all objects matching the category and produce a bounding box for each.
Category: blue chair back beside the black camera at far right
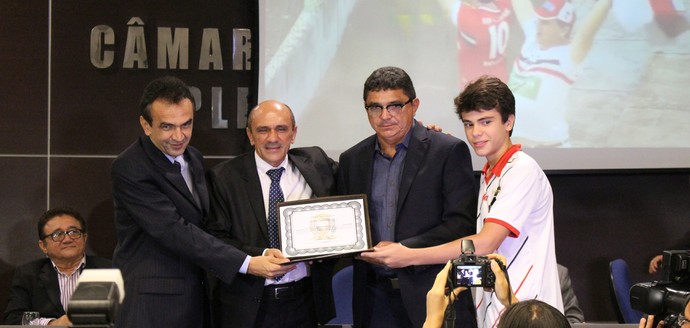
[609,259,644,323]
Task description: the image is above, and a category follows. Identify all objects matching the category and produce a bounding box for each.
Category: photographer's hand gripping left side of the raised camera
[423,261,467,328]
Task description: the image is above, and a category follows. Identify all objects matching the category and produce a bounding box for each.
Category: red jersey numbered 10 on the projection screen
[457,0,511,87]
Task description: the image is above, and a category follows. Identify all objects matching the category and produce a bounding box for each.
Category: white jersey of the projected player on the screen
[508,22,580,144]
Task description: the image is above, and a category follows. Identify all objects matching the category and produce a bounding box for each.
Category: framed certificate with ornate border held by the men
[278,194,371,262]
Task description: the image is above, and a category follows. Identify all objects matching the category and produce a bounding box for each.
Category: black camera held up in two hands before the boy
[451,240,496,288]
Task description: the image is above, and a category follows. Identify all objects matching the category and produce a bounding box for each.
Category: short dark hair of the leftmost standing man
[139,76,196,124]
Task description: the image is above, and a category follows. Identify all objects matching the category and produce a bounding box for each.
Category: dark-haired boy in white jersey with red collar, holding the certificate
[362,76,563,327]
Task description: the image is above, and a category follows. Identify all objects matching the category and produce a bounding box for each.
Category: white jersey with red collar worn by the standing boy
[475,145,563,327]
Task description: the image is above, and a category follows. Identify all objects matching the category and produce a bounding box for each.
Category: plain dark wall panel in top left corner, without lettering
[0,0,48,154]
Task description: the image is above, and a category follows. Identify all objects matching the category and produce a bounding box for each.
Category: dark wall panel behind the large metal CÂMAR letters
[51,0,258,156]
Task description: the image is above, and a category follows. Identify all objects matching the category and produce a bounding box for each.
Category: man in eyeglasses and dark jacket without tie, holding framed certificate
[337,67,477,328]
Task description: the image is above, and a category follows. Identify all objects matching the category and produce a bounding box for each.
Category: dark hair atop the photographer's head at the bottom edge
[497,300,570,328]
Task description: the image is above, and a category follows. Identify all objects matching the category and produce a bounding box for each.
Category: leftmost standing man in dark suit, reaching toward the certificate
[111,77,292,328]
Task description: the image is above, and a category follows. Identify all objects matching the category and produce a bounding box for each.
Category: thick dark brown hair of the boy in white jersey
[454,75,515,134]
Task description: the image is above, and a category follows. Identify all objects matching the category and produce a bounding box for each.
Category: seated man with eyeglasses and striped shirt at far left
[3,207,111,326]
